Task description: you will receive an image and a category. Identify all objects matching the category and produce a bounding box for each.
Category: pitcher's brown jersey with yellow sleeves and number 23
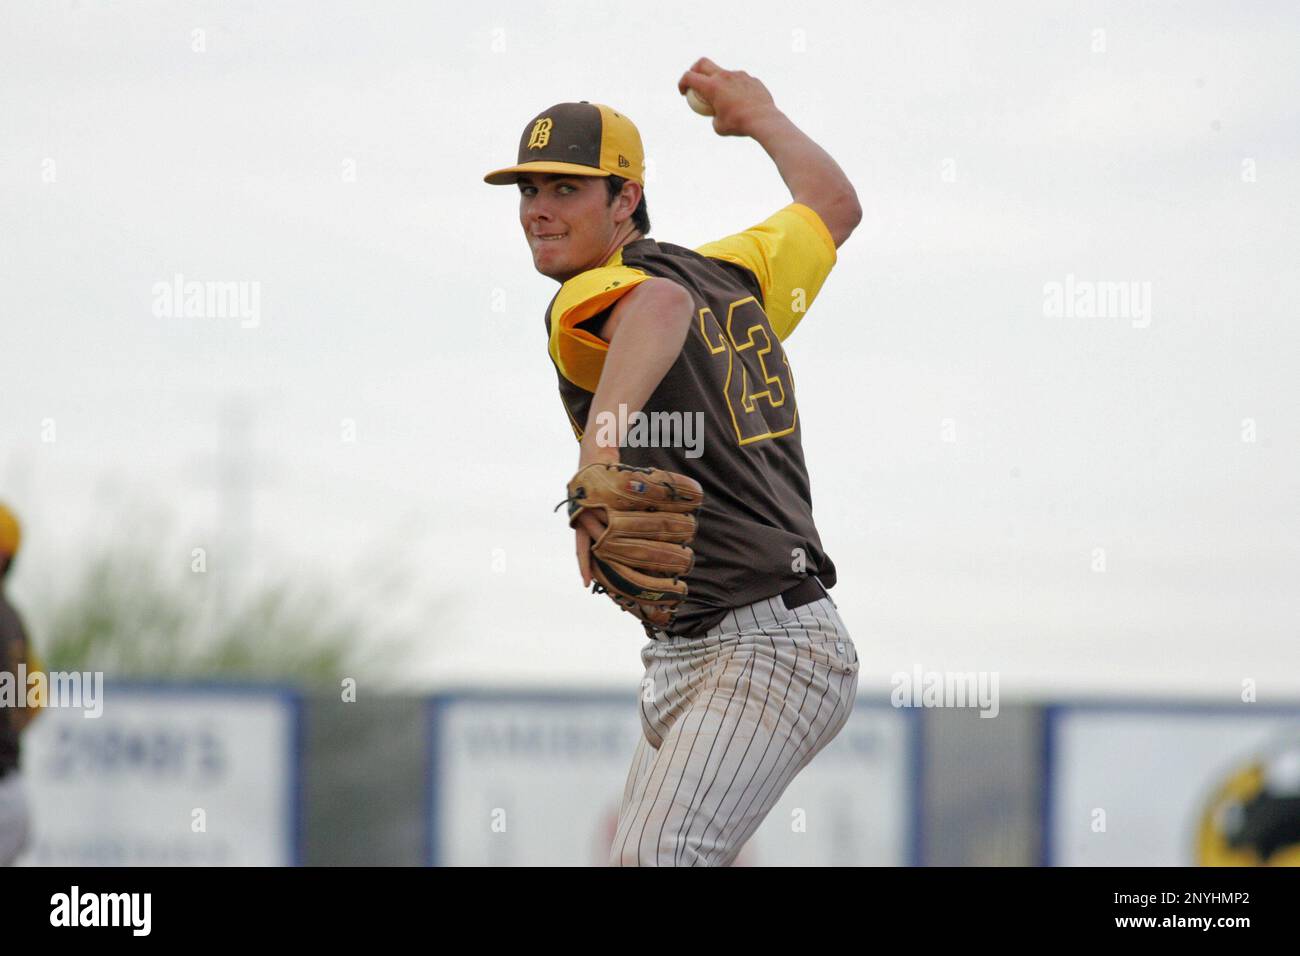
[546,203,836,636]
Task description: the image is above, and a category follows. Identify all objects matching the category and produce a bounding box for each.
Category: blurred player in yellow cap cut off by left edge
[0,503,40,866]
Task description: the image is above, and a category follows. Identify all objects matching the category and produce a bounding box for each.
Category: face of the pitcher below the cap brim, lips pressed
[519,173,619,282]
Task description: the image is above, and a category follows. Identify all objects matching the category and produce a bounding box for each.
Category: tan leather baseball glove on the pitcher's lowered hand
[556,463,705,631]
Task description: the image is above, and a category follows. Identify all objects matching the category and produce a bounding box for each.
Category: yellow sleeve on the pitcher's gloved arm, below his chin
[550,265,650,393]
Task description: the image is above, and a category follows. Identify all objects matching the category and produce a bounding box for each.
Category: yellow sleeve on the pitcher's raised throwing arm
[696,203,837,341]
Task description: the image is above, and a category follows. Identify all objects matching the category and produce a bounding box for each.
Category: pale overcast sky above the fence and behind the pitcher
[0,0,1300,700]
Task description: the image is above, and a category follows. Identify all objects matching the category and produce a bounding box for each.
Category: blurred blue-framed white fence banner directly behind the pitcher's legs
[429,693,920,866]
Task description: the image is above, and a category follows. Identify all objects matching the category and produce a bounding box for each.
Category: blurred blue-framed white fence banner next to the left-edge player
[21,682,303,866]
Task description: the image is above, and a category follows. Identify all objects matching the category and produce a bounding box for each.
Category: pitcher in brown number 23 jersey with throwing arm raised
[484,59,862,866]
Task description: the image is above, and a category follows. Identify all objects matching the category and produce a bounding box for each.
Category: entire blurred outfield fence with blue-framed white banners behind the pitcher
[12,682,1300,866]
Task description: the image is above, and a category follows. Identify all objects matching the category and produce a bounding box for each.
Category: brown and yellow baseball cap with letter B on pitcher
[484,100,646,187]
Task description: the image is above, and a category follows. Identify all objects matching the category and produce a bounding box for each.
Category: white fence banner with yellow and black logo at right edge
[1043,704,1300,866]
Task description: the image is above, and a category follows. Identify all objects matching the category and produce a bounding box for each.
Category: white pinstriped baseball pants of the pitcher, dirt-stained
[610,597,858,866]
